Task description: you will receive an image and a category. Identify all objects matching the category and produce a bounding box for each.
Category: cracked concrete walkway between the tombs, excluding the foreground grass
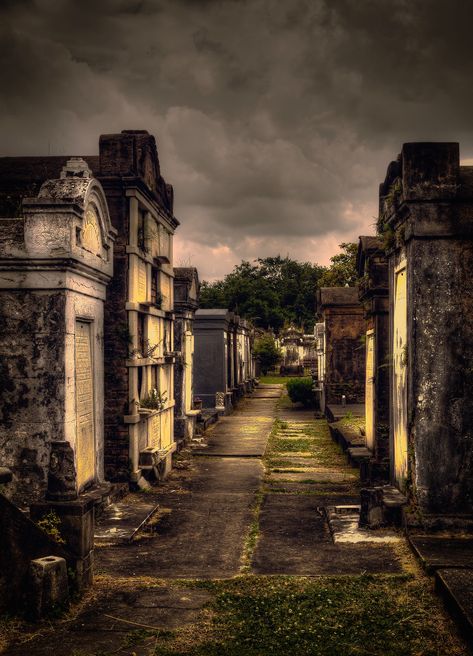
[0,385,464,656]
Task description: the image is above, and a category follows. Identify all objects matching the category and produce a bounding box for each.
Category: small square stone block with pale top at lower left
[28,556,69,619]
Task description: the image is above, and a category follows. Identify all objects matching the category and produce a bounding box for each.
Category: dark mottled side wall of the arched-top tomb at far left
[0,290,65,505]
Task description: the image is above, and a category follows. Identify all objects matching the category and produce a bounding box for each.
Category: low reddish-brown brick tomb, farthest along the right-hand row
[317,287,366,410]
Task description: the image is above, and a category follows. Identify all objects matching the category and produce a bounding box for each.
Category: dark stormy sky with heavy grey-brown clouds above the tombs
[0,0,473,279]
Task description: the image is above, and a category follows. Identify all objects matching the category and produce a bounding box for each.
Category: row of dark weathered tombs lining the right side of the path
[316,143,473,527]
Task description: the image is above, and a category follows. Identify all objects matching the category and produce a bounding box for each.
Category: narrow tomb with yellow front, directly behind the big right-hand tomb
[357,237,390,481]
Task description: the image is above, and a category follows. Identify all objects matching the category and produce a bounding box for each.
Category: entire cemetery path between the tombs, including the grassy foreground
[1,385,467,656]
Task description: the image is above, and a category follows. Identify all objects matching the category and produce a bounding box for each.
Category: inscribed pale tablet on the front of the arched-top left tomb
[75,321,95,490]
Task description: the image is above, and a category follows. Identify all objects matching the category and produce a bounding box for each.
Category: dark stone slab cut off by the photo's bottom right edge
[435,569,473,644]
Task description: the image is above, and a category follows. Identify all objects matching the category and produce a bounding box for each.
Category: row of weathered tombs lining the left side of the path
[0,131,254,507]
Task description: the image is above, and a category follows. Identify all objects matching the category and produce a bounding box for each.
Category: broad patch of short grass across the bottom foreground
[150,574,464,656]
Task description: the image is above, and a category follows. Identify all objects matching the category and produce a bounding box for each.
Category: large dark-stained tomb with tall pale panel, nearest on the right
[380,143,473,524]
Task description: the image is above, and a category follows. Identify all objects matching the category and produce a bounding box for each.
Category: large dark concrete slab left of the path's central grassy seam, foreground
[96,458,263,579]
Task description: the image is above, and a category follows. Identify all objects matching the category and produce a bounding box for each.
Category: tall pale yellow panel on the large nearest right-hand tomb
[392,262,408,489]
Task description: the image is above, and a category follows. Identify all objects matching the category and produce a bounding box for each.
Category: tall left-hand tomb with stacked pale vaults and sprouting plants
[97,130,179,486]
